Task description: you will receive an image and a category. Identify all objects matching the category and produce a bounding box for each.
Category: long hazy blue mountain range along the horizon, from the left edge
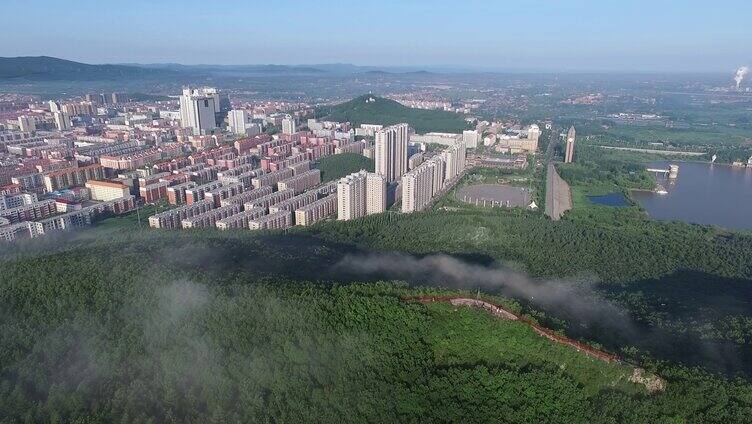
[0,56,440,81]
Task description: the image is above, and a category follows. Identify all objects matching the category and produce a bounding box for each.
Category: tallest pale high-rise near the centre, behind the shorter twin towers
[374,124,409,183]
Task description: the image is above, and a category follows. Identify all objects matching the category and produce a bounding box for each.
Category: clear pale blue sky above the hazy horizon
[0,0,752,72]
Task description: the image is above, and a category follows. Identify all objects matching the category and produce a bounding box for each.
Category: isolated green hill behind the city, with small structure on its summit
[317,94,468,134]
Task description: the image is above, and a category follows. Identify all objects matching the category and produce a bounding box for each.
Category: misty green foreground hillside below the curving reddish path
[0,231,752,423]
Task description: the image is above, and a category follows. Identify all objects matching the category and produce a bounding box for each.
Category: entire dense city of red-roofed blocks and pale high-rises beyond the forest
[0,87,483,241]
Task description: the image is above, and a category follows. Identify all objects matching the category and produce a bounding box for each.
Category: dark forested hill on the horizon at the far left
[0,56,172,81]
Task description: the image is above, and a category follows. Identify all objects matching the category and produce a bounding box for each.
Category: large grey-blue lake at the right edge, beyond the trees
[632,162,752,229]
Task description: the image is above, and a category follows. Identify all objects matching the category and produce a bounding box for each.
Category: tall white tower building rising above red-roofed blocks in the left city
[180,87,219,135]
